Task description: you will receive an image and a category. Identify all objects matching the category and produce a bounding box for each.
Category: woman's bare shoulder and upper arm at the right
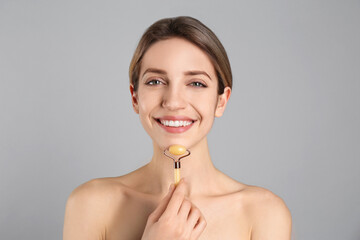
[239,186,292,240]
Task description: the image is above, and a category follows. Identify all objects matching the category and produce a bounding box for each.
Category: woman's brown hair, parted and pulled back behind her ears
[129,16,232,94]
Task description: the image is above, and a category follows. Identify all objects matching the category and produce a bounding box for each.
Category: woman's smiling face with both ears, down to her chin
[130,38,230,149]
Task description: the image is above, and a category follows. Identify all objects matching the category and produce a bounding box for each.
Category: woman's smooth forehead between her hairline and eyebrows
[140,38,216,78]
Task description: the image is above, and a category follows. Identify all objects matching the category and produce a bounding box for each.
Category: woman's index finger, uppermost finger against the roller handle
[163,179,188,218]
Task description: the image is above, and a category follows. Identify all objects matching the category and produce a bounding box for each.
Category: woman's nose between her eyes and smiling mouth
[162,85,186,111]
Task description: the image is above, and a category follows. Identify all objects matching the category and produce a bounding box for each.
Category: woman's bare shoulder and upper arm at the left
[63,178,124,240]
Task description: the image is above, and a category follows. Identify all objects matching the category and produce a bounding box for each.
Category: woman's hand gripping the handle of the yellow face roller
[141,179,206,240]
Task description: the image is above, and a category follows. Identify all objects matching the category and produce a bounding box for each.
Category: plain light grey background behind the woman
[0,0,360,240]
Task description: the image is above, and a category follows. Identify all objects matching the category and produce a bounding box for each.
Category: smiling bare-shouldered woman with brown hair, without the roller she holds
[64,17,291,240]
